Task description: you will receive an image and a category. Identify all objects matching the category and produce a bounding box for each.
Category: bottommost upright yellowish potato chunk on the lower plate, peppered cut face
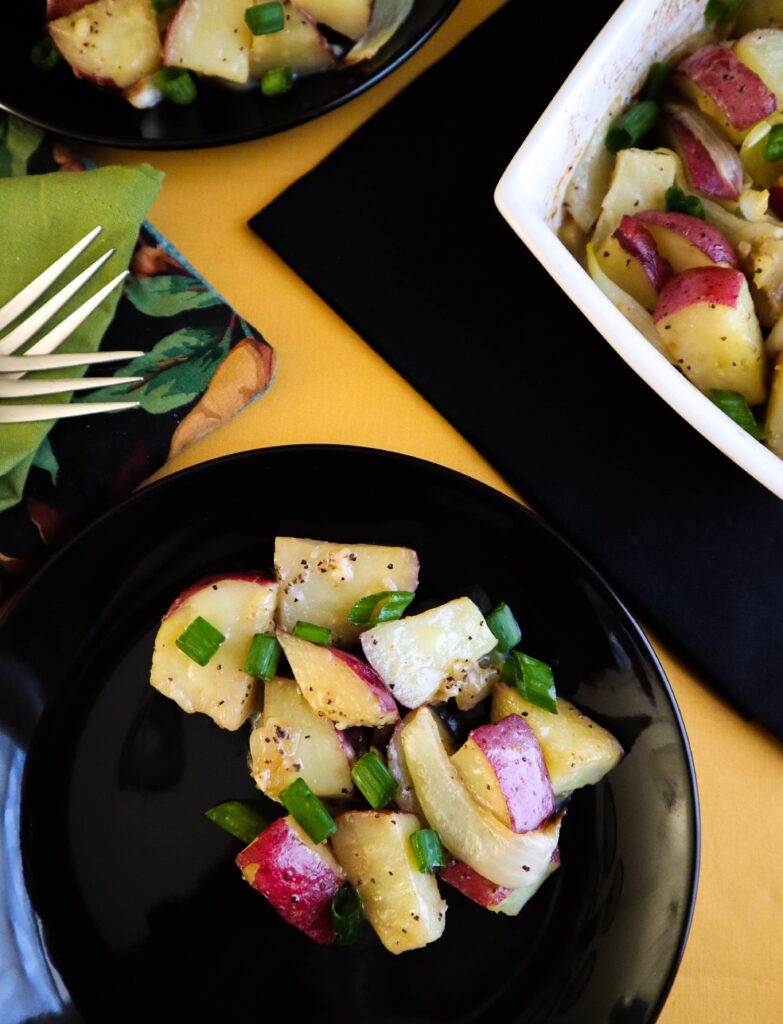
[332,811,446,953]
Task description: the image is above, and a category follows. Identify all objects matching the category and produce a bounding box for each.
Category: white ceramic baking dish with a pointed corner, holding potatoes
[495,0,783,498]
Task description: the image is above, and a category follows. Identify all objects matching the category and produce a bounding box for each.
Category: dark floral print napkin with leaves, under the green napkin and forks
[0,115,275,597]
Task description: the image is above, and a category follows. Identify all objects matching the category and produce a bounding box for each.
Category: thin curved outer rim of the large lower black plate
[0,443,701,1021]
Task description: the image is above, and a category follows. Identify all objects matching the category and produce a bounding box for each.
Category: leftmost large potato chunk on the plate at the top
[48,0,161,89]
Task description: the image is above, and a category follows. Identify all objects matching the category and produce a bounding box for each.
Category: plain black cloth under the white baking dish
[251,0,783,738]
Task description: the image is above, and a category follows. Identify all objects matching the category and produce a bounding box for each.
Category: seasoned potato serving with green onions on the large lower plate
[150,537,622,953]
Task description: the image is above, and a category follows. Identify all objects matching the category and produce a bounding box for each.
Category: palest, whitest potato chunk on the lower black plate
[361,597,497,708]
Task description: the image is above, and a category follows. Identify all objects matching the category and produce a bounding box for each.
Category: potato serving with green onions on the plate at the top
[31,0,414,109]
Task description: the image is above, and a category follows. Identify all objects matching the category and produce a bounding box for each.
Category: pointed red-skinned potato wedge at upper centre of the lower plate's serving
[277,630,399,729]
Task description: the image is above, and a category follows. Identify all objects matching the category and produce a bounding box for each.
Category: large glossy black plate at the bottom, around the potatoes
[0,445,699,1024]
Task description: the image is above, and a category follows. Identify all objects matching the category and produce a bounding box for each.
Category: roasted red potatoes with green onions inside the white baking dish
[561,0,783,458]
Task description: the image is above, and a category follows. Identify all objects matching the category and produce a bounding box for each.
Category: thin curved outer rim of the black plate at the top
[0,0,460,152]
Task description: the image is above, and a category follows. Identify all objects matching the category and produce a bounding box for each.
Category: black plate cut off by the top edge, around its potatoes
[0,0,458,150]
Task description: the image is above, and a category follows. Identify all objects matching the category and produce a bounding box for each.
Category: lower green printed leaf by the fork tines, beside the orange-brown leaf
[80,327,231,414]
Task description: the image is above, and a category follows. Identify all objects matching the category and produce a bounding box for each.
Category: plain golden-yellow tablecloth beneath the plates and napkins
[96,0,783,1024]
